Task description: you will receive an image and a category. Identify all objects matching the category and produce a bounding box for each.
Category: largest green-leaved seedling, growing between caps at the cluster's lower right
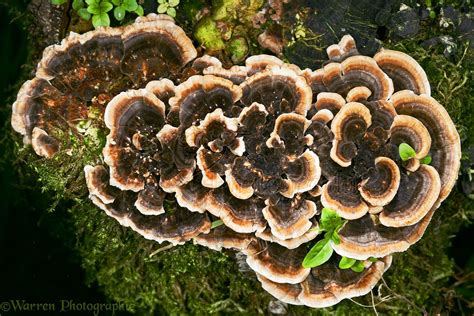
[303,207,345,269]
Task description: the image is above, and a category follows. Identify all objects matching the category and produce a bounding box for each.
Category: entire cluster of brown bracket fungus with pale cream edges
[12,15,461,307]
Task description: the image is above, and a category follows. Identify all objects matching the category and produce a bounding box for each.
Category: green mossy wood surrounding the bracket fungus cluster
[0,0,474,315]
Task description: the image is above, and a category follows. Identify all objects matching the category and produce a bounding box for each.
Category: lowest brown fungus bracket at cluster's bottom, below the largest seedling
[247,243,392,308]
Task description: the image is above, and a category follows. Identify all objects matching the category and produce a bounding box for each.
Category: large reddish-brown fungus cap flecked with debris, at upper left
[12,14,196,157]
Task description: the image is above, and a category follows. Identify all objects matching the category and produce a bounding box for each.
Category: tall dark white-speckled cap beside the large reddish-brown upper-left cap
[103,89,165,192]
